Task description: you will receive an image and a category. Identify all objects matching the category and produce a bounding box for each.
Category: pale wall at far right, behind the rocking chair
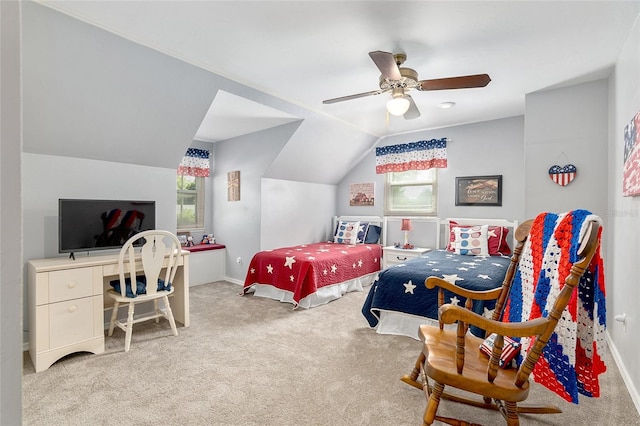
[605,16,640,411]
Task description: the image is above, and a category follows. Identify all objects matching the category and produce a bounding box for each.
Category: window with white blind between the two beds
[384,168,438,216]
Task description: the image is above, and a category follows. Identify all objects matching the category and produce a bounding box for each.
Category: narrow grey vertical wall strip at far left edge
[0,1,23,425]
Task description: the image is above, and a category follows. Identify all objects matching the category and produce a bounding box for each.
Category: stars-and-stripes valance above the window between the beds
[376,138,447,174]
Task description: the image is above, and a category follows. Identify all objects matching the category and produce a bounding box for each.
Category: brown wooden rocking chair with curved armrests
[401,211,604,426]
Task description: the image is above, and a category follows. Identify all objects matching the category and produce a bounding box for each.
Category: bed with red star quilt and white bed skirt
[243,220,382,308]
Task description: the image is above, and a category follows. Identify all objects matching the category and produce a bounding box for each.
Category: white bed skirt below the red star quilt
[249,271,380,309]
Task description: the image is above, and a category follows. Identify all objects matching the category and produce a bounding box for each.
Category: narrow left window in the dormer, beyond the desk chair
[176,175,204,229]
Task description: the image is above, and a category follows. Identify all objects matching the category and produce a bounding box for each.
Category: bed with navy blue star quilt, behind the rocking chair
[362,219,517,340]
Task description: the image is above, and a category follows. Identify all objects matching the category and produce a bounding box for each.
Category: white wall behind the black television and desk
[22,153,177,341]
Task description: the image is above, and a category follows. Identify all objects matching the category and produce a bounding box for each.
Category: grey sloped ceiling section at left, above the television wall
[23,2,217,168]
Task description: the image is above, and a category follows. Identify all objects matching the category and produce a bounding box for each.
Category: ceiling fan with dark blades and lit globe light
[322,50,491,120]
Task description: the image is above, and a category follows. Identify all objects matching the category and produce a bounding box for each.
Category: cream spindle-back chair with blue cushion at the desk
[107,230,182,352]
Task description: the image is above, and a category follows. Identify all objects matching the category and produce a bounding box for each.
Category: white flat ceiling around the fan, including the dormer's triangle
[38,0,640,141]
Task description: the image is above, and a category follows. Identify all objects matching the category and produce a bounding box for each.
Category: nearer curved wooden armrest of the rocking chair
[438,304,548,337]
